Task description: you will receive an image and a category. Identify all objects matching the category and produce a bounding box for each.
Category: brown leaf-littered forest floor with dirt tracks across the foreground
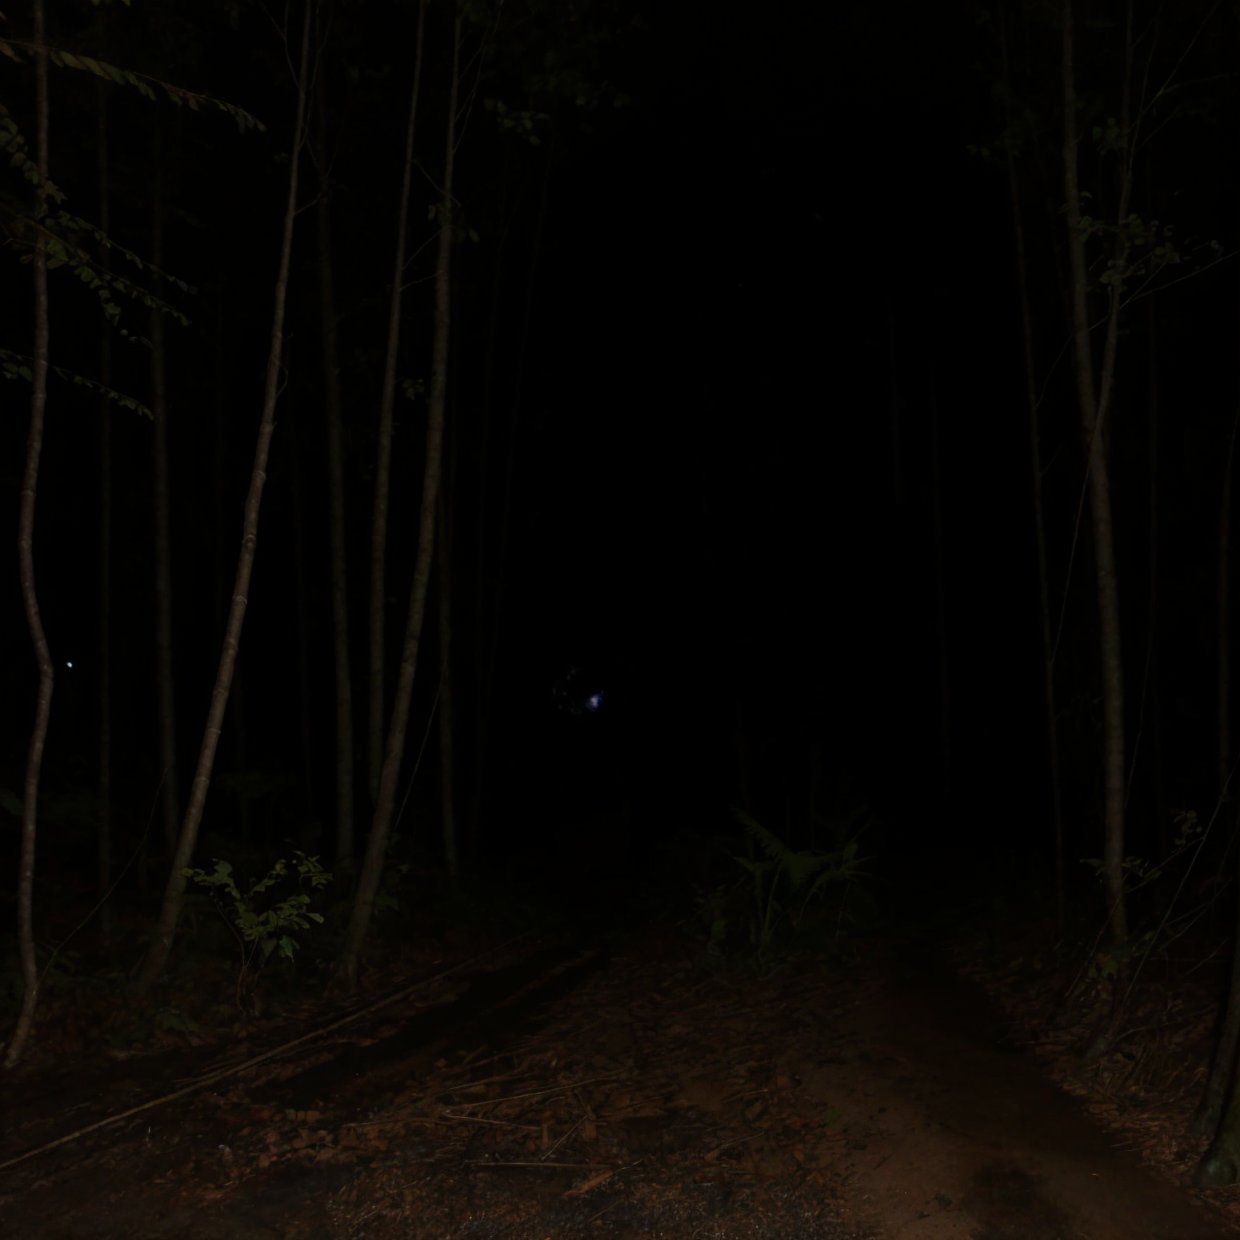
[0,887,1240,1240]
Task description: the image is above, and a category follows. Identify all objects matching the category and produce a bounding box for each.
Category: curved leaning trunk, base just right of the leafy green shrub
[339,17,461,990]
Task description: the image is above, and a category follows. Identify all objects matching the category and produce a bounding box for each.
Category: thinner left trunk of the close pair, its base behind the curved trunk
[367,0,427,805]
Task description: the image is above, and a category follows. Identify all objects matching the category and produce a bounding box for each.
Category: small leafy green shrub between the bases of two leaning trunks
[182,852,331,1012]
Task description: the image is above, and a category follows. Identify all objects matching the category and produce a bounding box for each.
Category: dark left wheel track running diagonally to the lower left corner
[0,941,606,1240]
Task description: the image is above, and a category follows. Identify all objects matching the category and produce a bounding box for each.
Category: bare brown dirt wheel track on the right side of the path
[815,947,1235,1240]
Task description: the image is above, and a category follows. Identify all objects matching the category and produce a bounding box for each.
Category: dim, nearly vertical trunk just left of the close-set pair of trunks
[317,116,357,880]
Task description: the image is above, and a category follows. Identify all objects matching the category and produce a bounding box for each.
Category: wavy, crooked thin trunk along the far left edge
[4,0,56,1069]
